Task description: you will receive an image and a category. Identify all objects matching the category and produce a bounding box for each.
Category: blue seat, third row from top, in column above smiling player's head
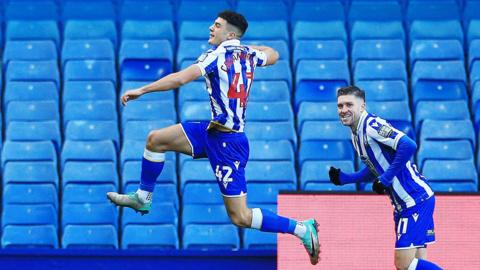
[352,39,406,66]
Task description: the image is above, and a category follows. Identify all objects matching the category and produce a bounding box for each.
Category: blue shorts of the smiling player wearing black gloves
[394,196,435,249]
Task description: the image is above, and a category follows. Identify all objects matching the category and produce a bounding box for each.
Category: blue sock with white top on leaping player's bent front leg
[137,149,165,203]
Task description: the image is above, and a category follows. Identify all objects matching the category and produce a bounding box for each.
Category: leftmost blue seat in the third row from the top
[3,40,58,65]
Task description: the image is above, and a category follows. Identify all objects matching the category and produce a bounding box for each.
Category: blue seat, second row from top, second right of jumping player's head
[292,21,347,43]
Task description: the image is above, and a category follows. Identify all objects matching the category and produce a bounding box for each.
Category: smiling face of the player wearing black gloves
[337,95,365,127]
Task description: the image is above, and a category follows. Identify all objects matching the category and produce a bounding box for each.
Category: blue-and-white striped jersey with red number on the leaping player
[196,39,267,132]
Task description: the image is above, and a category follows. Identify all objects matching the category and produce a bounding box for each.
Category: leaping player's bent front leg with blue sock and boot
[107,124,201,214]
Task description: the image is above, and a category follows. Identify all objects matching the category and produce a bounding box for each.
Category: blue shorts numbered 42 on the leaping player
[182,121,250,197]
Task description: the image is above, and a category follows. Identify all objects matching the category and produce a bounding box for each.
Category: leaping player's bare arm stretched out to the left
[121,65,202,106]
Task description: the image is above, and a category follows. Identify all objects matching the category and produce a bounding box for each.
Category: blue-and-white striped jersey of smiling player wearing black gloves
[352,111,433,211]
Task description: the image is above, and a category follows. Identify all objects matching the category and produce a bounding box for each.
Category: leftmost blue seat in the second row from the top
[5,20,60,47]
